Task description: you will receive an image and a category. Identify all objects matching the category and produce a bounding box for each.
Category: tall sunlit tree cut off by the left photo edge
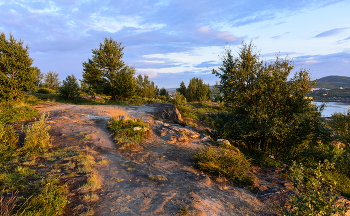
[0,33,36,100]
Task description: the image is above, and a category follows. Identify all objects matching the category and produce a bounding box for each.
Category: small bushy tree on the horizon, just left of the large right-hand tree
[186,77,211,102]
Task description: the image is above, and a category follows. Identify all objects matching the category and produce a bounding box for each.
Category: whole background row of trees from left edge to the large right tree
[0,33,217,102]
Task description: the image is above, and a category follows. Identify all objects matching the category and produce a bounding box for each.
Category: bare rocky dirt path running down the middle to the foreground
[37,104,274,216]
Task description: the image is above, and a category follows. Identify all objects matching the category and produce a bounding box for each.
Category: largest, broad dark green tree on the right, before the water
[213,43,329,157]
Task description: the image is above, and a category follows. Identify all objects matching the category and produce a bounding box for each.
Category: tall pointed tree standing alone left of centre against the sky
[83,38,136,100]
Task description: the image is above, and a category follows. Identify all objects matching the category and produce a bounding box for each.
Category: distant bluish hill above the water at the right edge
[313,76,350,89]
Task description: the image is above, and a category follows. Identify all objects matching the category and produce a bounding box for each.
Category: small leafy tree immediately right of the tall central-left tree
[136,74,159,98]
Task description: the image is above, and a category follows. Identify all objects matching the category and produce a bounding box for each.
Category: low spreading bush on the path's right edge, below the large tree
[193,147,251,185]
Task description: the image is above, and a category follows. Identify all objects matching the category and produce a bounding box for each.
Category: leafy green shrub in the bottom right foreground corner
[284,162,345,216]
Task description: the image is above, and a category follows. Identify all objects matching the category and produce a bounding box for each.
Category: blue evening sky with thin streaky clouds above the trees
[0,0,350,88]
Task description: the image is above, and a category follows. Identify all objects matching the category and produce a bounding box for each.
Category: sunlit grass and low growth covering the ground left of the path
[0,100,104,216]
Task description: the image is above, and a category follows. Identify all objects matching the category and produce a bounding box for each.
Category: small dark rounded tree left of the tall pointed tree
[59,74,80,99]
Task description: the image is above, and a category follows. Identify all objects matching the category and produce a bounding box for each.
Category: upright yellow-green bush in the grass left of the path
[23,115,51,153]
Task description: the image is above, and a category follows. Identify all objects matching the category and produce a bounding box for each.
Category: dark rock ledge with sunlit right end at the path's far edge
[147,103,184,124]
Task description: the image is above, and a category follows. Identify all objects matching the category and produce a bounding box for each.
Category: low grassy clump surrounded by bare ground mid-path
[108,118,150,150]
